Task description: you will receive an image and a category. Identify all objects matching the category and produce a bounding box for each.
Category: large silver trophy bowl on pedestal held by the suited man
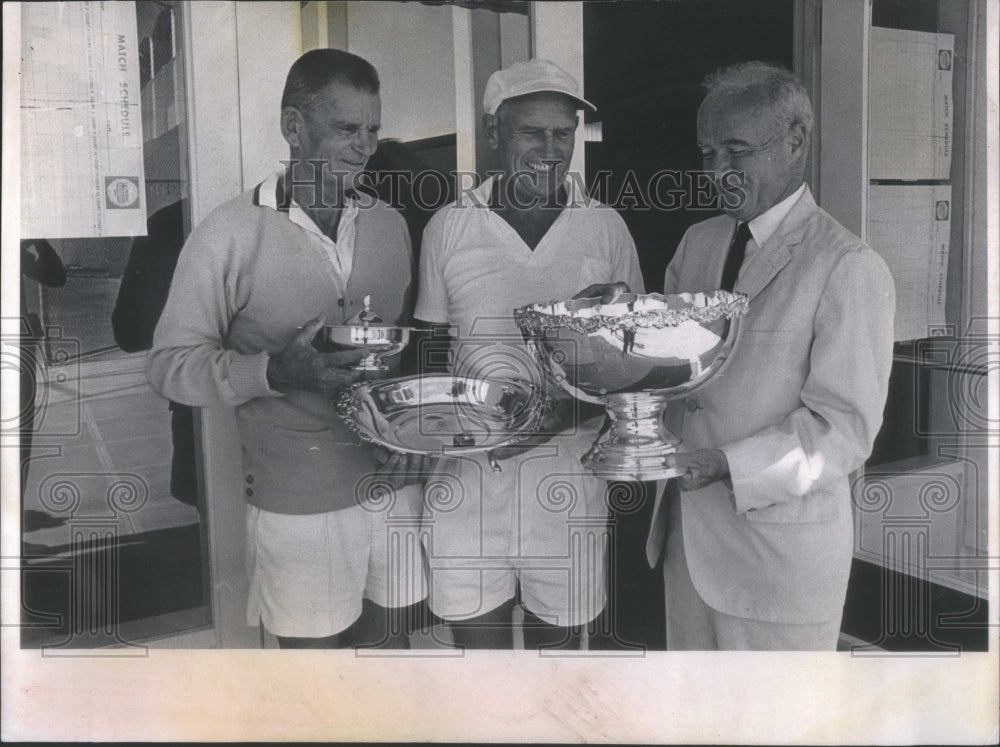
[514,290,747,480]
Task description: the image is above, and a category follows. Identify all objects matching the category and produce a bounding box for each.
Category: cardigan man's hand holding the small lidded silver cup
[267,317,365,393]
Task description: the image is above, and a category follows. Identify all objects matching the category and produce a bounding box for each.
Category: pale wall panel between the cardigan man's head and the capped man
[340,2,455,140]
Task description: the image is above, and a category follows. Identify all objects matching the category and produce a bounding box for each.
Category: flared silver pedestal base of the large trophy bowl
[580,392,680,480]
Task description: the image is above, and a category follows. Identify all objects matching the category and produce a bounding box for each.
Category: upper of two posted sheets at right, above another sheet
[868,26,955,180]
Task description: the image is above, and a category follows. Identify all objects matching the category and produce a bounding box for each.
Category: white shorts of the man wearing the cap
[422,432,608,626]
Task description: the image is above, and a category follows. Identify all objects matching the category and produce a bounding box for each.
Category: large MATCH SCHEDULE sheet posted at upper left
[21,2,146,239]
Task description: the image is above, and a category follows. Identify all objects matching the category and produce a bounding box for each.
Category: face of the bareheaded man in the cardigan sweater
[281,81,382,204]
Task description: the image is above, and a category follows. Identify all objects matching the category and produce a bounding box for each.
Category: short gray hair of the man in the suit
[702,60,812,132]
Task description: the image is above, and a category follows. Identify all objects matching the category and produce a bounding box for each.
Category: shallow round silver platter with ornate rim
[337,375,545,455]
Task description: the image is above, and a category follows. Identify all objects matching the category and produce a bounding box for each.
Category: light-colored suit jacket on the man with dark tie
[647,189,895,623]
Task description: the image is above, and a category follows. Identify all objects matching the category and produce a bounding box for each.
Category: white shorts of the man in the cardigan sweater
[246,485,427,638]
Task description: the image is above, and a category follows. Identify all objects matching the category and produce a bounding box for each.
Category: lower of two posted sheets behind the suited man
[868,184,951,341]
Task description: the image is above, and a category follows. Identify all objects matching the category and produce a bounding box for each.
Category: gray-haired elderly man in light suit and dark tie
[632,62,895,650]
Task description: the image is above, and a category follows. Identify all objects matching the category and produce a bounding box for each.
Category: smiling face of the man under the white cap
[485,93,577,205]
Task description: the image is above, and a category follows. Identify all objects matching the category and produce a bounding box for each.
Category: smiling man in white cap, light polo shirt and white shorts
[415,60,643,649]
